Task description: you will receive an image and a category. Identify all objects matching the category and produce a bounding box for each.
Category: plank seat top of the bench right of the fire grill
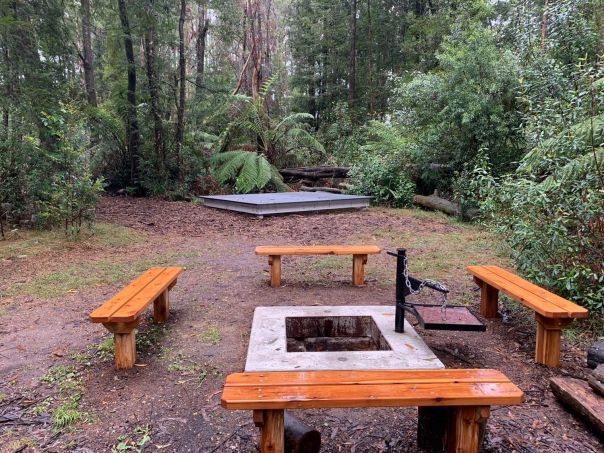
[468,266,588,318]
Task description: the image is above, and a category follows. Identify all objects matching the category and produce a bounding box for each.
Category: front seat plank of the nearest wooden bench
[222,370,523,410]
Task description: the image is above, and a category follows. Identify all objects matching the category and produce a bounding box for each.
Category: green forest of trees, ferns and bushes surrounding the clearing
[0,0,604,312]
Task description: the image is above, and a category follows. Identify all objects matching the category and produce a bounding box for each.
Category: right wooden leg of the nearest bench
[447,406,491,453]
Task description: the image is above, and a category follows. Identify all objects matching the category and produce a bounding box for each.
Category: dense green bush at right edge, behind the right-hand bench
[471,64,604,313]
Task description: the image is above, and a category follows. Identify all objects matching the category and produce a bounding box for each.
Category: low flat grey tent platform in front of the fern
[200,192,371,216]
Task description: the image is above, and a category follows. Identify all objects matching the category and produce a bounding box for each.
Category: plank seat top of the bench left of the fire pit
[90,267,184,323]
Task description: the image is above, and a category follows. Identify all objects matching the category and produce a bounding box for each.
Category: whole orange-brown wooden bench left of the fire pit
[90,267,184,368]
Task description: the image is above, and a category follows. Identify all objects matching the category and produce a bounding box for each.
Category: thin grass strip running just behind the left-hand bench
[3,252,197,299]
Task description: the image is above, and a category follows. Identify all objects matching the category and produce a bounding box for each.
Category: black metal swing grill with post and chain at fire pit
[388,249,487,332]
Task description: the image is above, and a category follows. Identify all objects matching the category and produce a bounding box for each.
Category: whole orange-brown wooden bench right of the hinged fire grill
[468,266,588,367]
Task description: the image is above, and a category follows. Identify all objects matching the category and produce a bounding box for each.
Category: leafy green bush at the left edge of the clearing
[0,104,103,236]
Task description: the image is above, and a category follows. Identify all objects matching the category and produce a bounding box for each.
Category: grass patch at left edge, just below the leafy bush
[0,223,147,259]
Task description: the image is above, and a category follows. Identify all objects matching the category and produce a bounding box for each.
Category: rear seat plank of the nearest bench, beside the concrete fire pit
[226,369,510,387]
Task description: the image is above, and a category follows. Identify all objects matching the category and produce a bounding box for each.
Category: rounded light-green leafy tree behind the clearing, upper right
[394,21,522,191]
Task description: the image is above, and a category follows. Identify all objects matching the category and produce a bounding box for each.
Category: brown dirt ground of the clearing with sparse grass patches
[0,197,604,453]
